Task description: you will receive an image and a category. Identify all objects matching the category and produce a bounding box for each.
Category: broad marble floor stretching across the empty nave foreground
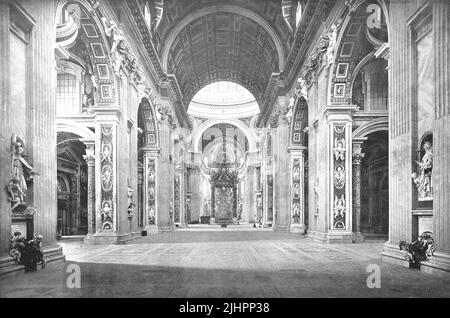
[0,226,450,298]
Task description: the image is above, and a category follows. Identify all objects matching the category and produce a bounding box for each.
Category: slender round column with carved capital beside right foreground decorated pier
[352,138,367,243]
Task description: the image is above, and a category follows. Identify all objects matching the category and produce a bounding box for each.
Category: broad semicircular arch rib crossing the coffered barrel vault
[160,4,285,72]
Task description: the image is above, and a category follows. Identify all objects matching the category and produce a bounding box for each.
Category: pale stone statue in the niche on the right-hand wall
[411,141,433,201]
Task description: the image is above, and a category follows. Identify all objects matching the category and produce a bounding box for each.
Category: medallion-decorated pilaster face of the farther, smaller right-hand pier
[289,147,306,234]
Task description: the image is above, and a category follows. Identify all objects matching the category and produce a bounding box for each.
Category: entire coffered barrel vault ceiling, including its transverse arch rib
[155,0,292,104]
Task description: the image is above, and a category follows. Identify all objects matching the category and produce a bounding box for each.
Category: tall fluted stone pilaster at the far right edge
[421,0,450,272]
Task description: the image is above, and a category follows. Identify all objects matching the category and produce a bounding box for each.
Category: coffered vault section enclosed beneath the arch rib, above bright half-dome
[167,12,279,101]
